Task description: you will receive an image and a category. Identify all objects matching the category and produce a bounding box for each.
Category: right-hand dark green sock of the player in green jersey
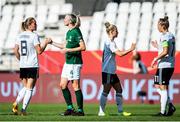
[75,90,83,112]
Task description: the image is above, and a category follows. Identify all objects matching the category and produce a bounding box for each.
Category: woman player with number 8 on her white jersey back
[12,17,51,115]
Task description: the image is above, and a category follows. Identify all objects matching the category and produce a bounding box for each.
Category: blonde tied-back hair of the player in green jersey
[69,14,81,27]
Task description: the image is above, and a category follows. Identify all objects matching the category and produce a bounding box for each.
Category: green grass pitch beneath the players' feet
[0,103,180,121]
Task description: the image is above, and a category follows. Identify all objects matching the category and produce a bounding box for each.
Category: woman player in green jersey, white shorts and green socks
[52,14,86,116]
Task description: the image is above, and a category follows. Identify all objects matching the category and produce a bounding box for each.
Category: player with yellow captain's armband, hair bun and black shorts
[151,16,176,116]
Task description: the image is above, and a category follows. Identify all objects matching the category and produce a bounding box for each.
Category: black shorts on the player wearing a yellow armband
[154,68,174,85]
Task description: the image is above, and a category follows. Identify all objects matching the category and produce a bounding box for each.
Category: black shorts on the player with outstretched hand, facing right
[102,72,120,85]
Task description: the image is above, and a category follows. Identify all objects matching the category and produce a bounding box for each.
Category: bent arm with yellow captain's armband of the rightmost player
[151,41,168,67]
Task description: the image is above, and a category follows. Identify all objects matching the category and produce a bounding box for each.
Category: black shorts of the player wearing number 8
[20,68,39,79]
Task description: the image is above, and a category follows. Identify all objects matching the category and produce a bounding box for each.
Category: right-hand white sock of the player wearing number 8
[22,89,33,111]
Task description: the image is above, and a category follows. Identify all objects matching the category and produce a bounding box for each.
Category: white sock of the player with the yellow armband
[161,90,168,114]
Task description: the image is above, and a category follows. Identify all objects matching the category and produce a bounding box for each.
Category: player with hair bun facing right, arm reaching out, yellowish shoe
[98,22,135,116]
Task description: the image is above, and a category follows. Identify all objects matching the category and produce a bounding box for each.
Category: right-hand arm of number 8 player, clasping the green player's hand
[35,38,52,54]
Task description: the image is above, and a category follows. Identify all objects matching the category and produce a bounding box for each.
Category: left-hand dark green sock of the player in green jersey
[62,88,73,109]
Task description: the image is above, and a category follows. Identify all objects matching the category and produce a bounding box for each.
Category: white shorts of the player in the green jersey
[61,63,82,80]
